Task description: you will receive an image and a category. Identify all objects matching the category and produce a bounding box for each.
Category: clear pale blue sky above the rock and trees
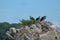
[0,0,60,23]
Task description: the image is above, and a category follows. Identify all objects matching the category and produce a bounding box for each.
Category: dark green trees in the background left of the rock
[0,22,21,40]
